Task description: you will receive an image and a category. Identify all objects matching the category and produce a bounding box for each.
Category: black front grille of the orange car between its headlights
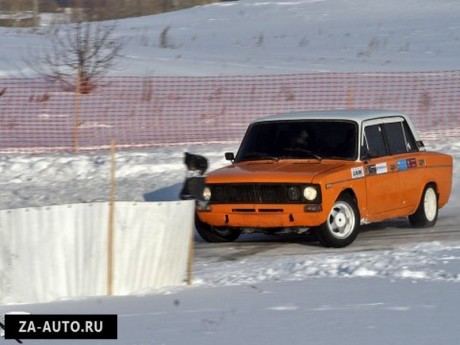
[208,183,306,204]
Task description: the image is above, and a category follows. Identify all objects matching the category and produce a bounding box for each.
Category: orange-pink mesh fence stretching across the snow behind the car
[0,71,460,152]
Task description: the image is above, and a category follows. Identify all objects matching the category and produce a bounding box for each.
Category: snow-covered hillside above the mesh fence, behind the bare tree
[0,0,460,76]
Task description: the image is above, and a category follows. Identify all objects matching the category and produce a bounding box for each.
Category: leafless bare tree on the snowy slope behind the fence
[26,20,122,93]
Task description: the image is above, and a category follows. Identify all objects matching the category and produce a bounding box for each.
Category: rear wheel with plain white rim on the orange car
[409,184,439,228]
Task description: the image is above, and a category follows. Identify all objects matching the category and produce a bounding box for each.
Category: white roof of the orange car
[254,109,410,123]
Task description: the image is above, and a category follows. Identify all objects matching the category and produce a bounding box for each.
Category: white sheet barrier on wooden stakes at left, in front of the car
[0,201,194,304]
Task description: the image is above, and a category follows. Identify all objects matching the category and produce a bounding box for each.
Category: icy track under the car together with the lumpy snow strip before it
[194,217,460,286]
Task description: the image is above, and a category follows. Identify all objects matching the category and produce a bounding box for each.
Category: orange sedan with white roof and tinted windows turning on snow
[181,110,453,247]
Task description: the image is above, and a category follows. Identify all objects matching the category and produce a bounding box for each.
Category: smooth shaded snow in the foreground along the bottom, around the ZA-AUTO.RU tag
[2,272,460,345]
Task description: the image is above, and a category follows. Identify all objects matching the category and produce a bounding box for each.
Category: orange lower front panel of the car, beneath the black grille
[198,204,327,228]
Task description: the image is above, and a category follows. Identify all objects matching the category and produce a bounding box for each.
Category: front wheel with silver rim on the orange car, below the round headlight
[316,195,360,248]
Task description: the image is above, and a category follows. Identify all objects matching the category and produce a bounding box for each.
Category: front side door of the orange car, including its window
[361,119,401,220]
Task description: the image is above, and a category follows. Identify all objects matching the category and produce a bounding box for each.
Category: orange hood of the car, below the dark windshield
[206,160,345,183]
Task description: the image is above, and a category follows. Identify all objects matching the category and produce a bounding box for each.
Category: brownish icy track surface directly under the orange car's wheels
[195,213,460,262]
